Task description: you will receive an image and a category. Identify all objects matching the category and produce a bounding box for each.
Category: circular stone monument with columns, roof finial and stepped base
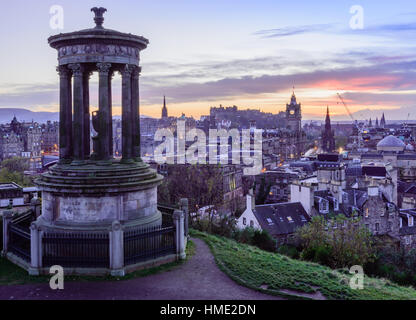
[36,8,162,232]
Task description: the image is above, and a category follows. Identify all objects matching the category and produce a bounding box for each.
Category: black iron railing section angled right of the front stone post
[124,226,176,265]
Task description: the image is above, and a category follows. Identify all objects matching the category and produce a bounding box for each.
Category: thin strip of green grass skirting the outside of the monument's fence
[0,241,195,285]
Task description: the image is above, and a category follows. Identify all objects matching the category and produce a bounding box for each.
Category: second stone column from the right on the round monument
[121,65,134,163]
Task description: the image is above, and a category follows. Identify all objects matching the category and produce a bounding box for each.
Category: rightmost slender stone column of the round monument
[131,66,142,162]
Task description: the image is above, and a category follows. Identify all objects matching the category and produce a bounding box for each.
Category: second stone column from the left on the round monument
[69,63,85,165]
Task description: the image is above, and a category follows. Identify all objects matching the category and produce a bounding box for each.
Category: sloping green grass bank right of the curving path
[191,230,416,300]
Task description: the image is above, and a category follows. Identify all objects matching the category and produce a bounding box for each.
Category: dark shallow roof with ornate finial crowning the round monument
[48,7,149,48]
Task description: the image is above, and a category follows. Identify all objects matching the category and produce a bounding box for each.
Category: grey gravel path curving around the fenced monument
[0,239,282,300]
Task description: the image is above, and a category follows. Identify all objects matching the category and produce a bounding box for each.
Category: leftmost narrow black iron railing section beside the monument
[8,222,30,262]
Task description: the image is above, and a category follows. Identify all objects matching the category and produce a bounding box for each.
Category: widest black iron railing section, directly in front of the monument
[42,233,110,268]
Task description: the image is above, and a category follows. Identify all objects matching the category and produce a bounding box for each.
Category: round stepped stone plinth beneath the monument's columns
[36,161,162,227]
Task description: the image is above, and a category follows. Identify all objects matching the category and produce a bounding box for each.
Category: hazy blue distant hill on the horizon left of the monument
[0,108,59,124]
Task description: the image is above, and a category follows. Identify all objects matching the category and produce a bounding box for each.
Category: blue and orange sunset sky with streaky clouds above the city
[0,0,416,121]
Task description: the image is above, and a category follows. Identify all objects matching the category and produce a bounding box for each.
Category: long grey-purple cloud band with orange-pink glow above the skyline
[142,55,416,104]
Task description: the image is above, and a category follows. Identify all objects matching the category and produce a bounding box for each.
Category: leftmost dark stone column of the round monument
[56,66,73,163]
